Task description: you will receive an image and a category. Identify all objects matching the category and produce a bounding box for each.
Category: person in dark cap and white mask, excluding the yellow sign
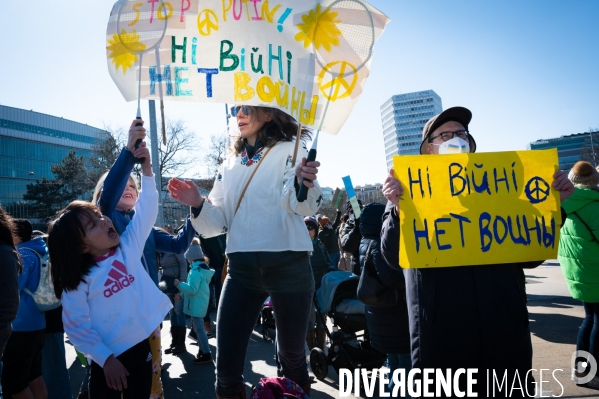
[381,107,574,397]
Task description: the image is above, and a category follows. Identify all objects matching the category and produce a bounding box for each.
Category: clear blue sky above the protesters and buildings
[0,0,599,187]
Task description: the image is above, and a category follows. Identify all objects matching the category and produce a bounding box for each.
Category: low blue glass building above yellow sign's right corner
[527,133,599,171]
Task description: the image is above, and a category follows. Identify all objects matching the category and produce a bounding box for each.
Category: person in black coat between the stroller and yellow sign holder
[359,203,412,392]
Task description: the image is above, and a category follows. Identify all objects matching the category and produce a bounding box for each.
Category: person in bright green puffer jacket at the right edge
[558,161,599,389]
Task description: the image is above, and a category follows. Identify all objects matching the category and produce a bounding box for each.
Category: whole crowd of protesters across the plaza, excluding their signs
[0,105,599,399]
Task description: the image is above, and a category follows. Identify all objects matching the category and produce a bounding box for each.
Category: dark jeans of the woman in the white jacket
[215,251,314,397]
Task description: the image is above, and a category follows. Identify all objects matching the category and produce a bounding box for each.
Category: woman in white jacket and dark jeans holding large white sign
[168,105,322,398]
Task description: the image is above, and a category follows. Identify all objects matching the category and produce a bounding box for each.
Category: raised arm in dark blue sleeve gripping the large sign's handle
[98,119,146,215]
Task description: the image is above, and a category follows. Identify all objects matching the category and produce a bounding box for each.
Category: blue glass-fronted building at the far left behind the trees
[0,105,106,218]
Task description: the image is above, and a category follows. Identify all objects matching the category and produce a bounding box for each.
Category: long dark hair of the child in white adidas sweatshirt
[48,201,101,298]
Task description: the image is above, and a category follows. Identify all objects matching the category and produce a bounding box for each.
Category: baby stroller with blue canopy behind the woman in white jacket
[310,271,387,380]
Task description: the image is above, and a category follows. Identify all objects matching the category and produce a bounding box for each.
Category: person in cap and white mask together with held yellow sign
[381,107,574,397]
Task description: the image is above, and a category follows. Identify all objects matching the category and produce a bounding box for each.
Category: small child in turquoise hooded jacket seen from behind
[175,238,214,364]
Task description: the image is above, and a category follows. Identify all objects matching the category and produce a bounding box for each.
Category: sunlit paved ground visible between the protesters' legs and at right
[67,261,599,399]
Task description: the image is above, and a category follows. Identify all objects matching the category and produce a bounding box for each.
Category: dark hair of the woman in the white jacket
[233,105,312,155]
